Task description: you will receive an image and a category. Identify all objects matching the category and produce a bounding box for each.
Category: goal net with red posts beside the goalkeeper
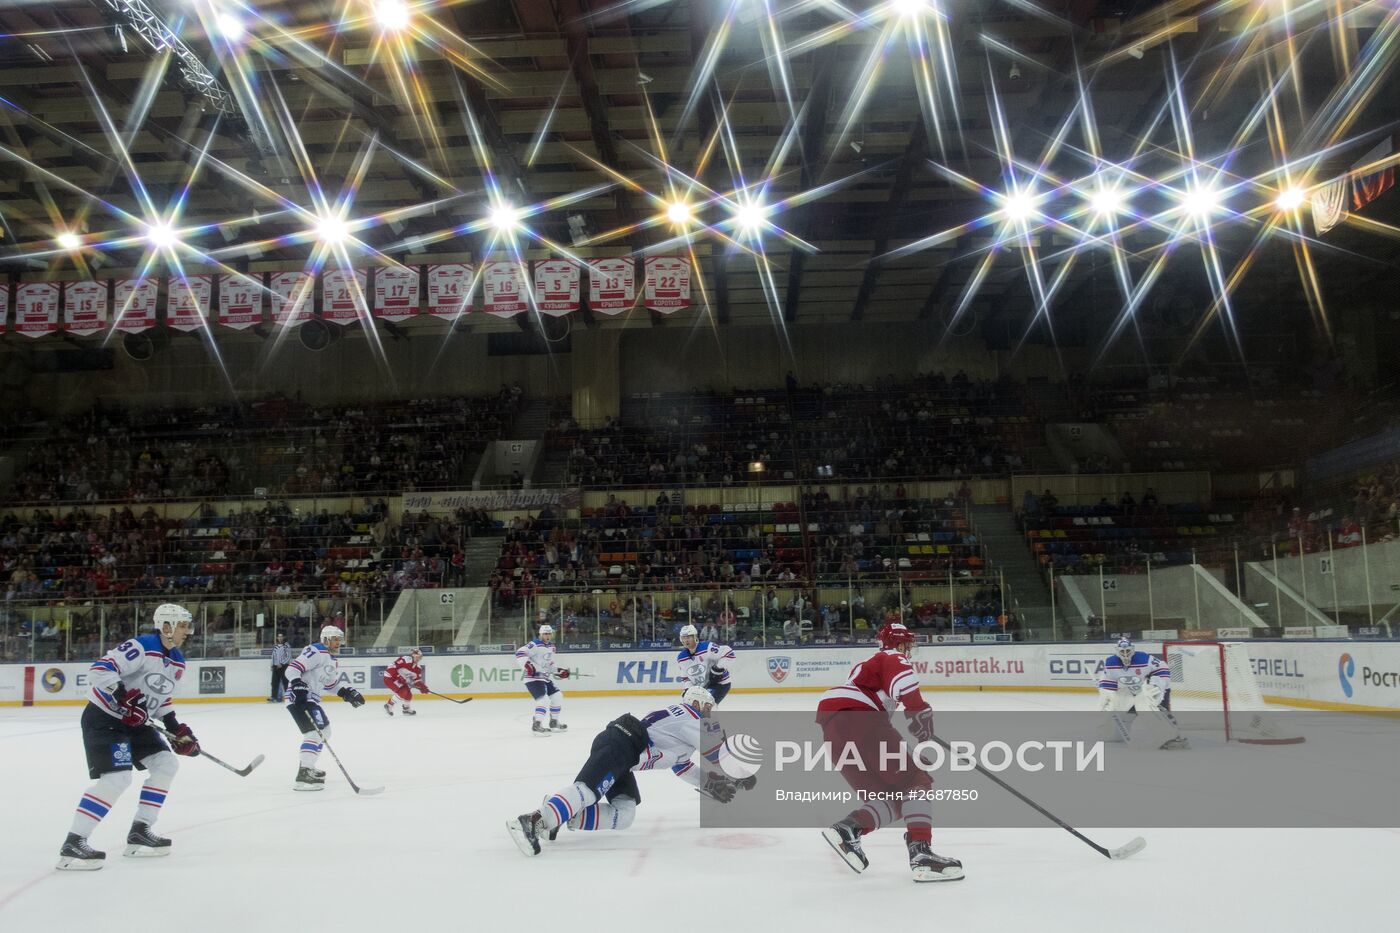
[1162,642,1303,745]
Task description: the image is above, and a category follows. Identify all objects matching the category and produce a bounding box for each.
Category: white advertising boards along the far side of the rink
[0,640,1400,712]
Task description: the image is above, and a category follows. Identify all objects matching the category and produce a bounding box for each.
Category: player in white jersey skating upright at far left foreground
[57,602,199,871]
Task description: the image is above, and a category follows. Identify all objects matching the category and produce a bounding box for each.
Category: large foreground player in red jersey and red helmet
[816,622,963,881]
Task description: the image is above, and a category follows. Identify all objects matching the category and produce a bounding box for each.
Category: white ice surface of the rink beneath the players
[0,692,1400,933]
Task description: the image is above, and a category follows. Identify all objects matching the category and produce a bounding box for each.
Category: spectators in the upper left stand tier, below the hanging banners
[6,387,521,503]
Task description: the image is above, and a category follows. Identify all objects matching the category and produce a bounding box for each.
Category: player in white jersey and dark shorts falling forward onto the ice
[505,686,757,856]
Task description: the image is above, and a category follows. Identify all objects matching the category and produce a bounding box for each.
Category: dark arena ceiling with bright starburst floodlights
[0,0,1400,348]
